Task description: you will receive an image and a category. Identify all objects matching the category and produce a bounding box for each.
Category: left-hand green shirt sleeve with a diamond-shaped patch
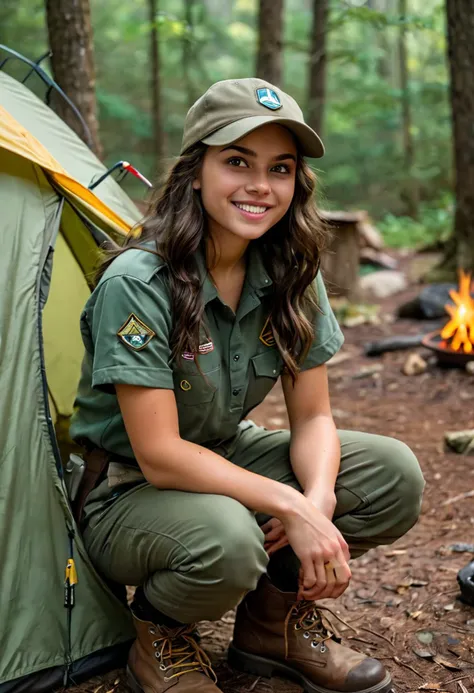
[81,276,173,393]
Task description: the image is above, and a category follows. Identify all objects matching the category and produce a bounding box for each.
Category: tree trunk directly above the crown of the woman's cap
[256,0,283,87]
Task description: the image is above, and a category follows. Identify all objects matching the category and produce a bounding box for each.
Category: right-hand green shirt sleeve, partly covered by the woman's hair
[300,272,344,371]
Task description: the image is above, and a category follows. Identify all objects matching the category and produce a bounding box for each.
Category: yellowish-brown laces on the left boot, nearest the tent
[148,624,217,683]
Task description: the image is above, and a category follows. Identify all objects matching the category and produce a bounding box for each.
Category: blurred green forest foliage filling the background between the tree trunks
[0,0,452,245]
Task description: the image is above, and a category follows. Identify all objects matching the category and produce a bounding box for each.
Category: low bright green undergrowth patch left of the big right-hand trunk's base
[378,195,453,248]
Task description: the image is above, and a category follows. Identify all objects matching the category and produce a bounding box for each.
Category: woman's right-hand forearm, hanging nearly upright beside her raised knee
[290,415,341,517]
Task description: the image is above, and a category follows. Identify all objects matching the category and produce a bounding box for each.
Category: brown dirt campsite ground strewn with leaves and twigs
[72,253,474,693]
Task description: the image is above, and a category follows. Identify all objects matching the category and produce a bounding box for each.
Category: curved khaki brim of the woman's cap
[202,115,324,159]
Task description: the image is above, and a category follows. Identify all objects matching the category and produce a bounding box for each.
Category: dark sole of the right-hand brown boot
[228,643,392,693]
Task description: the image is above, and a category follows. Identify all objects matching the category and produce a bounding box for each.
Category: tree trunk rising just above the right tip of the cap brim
[307,0,329,135]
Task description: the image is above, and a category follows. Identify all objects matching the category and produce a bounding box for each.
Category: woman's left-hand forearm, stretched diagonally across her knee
[137,438,302,519]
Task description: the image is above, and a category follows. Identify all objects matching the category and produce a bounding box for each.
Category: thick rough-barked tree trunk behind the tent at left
[46,0,102,158]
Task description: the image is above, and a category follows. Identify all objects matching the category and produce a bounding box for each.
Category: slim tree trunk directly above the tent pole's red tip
[148,0,165,172]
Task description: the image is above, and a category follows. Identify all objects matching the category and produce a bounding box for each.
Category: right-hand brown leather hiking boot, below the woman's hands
[229,576,391,693]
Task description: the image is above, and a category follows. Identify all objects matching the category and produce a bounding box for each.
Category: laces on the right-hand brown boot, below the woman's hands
[285,600,356,659]
